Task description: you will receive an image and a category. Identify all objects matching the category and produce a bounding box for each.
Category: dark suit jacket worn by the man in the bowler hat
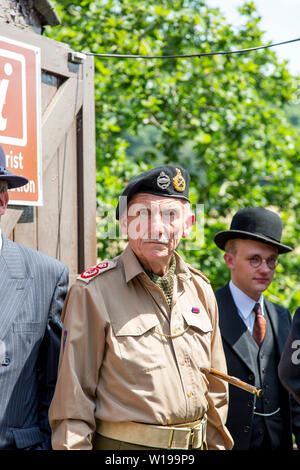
[216,284,300,450]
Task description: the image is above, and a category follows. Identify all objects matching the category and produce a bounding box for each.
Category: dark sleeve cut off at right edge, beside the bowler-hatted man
[278,307,300,403]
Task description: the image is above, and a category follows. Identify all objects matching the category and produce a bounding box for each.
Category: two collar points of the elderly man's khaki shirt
[121,244,192,283]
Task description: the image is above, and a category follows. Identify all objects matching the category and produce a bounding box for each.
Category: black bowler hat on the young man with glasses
[214,207,293,253]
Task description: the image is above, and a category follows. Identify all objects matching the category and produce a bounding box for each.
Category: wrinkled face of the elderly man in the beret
[122,193,192,262]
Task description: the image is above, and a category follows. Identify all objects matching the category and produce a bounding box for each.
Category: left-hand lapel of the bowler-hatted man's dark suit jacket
[216,284,255,372]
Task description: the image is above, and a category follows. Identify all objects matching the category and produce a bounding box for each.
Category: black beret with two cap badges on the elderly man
[116,165,190,220]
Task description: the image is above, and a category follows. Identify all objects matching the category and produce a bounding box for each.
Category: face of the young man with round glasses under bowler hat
[224,239,278,300]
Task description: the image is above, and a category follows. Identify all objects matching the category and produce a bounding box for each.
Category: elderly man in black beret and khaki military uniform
[50,165,233,450]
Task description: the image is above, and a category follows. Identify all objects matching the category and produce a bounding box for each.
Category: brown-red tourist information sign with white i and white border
[0,36,42,206]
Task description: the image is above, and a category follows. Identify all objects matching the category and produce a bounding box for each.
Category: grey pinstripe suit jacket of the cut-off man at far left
[0,237,68,449]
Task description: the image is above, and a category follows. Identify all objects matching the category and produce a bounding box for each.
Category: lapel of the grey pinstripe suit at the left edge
[0,236,32,340]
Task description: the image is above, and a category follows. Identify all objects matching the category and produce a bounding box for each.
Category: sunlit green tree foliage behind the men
[46,0,300,311]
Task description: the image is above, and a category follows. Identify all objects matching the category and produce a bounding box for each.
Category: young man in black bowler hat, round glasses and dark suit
[214,207,300,451]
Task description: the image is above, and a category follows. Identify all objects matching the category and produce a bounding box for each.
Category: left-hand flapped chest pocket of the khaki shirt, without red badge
[115,314,166,373]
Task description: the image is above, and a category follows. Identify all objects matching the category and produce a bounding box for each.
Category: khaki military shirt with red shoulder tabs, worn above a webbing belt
[49,245,232,449]
